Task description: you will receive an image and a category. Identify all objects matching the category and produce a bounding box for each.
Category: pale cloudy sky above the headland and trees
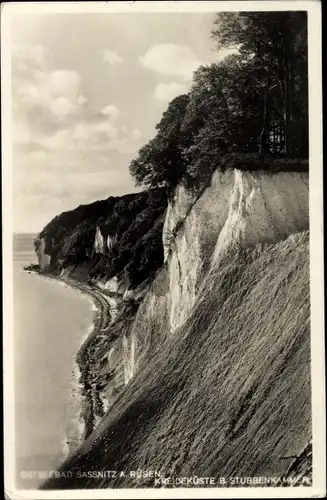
[11,13,233,232]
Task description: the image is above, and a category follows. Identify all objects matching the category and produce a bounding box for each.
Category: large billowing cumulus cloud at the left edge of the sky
[13,47,139,154]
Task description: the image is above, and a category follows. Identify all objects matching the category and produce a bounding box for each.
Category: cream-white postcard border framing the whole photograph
[1,0,326,500]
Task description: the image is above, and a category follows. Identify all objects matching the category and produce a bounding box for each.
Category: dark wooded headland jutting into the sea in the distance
[40,189,166,288]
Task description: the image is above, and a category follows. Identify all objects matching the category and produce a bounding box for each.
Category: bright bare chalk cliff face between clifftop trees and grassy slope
[98,170,309,414]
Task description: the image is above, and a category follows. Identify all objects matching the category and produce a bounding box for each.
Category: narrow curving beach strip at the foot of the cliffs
[28,270,111,450]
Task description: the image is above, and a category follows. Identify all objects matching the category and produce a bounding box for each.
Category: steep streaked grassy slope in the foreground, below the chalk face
[44,233,311,488]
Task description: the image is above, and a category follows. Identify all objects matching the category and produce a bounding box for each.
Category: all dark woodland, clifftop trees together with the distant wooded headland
[40,11,308,288]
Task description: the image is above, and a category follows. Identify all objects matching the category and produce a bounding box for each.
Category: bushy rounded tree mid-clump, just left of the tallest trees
[182,54,270,178]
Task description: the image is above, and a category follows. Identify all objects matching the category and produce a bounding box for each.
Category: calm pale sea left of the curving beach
[12,234,95,489]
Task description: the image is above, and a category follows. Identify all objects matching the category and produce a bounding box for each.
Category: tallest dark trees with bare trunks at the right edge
[212,11,308,154]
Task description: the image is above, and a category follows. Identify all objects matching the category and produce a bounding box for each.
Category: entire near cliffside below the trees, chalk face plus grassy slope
[40,168,311,488]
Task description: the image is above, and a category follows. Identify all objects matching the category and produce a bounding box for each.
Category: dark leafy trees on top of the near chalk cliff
[130,12,308,189]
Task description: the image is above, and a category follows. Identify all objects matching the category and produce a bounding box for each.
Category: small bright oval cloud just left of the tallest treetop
[140,43,204,80]
